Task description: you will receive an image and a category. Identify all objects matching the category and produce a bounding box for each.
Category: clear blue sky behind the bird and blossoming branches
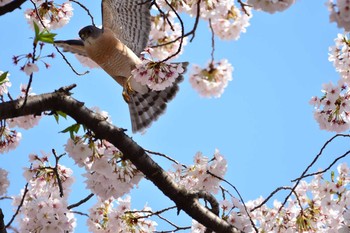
[0,1,349,232]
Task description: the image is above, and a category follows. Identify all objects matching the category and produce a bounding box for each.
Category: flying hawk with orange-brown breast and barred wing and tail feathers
[55,0,187,133]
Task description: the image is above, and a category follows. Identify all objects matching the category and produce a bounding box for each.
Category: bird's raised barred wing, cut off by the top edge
[102,0,151,56]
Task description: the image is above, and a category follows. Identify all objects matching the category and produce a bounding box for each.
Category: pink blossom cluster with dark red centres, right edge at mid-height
[310,81,350,133]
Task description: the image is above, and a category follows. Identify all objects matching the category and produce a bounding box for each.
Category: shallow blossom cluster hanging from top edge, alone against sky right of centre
[247,0,295,14]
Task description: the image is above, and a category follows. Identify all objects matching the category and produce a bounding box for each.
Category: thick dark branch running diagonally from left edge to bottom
[0,88,239,233]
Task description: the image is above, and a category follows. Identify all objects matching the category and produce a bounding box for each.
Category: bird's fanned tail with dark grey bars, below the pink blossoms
[129,62,188,133]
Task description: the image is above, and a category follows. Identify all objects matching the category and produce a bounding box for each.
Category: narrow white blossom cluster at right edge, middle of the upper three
[328,34,350,85]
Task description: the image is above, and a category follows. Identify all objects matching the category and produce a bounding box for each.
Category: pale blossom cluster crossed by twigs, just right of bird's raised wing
[148,11,187,60]
